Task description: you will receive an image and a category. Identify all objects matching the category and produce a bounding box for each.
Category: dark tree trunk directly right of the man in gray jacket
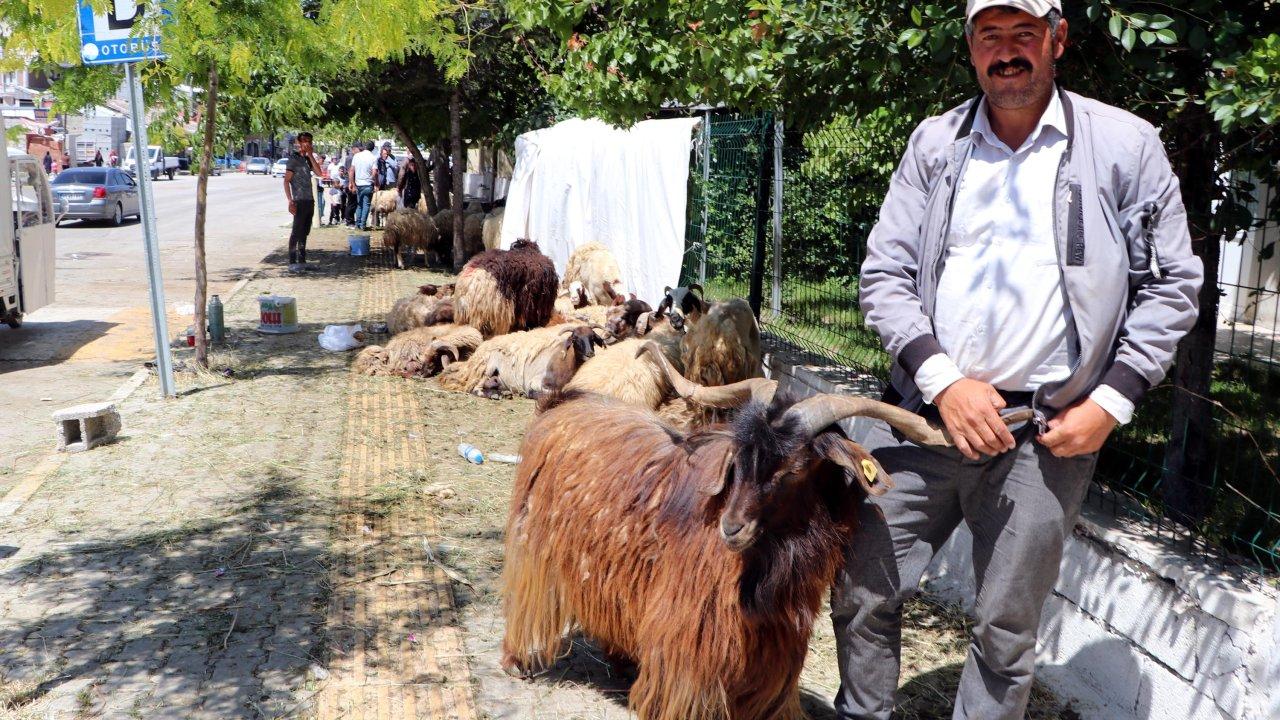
[1161,104,1222,528]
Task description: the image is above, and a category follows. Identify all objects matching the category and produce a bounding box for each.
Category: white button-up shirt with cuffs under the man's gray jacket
[915,92,1133,424]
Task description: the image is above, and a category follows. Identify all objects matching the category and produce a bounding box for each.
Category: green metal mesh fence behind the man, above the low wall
[682,114,1280,573]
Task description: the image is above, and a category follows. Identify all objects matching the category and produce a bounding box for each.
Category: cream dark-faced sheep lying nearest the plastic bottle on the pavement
[440,323,604,398]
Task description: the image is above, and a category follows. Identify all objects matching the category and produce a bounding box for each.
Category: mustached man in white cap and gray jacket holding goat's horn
[832,0,1203,720]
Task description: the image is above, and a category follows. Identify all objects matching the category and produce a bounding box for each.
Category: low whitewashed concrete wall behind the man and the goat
[767,351,1280,720]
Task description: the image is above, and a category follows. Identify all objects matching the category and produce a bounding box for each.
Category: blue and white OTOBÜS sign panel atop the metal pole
[76,0,169,65]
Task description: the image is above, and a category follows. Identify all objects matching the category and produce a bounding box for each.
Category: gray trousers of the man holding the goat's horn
[831,412,1097,720]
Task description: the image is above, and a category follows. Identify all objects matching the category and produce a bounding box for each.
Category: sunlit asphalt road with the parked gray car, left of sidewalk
[0,174,289,468]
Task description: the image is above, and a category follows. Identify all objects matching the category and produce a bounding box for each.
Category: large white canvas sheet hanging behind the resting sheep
[502,118,700,306]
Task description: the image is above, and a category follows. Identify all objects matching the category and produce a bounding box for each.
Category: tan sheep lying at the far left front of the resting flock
[352,319,481,378]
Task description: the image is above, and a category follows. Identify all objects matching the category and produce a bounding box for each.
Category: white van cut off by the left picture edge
[0,144,58,328]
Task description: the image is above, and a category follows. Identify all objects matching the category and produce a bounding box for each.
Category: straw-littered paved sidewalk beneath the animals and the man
[0,228,1071,720]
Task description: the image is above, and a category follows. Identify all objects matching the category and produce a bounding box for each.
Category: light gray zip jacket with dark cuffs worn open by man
[860,91,1204,414]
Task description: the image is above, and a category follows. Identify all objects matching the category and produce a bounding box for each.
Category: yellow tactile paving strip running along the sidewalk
[317,248,479,720]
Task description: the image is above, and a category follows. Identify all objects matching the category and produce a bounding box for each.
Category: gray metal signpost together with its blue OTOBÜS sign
[76,0,175,397]
